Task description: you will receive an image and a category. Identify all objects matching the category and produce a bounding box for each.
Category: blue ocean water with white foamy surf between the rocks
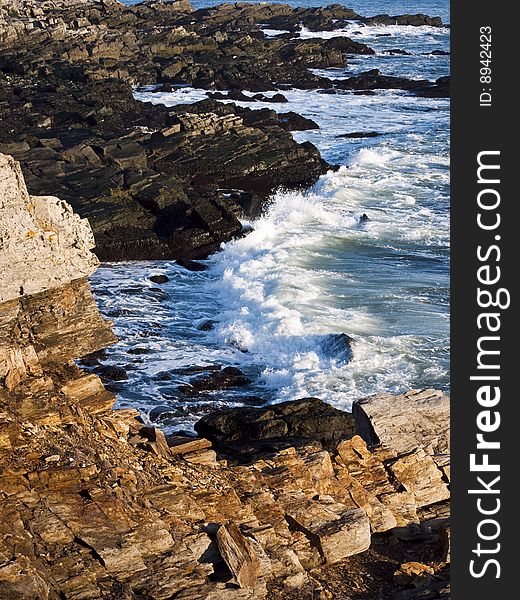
[92,0,449,430]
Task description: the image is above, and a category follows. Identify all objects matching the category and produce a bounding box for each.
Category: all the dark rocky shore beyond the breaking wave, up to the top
[0,0,449,260]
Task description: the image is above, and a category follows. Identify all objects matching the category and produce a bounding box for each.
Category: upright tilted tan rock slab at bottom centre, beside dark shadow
[217,523,260,589]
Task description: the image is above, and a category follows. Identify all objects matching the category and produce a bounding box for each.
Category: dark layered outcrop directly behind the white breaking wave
[0,78,327,260]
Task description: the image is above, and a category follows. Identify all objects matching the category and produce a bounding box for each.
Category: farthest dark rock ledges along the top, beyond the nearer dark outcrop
[0,0,442,91]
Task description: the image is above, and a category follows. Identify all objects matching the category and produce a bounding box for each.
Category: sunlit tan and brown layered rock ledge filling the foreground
[0,158,449,600]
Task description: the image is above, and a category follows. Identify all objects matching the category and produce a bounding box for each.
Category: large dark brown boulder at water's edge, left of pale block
[195,398,356,458]
